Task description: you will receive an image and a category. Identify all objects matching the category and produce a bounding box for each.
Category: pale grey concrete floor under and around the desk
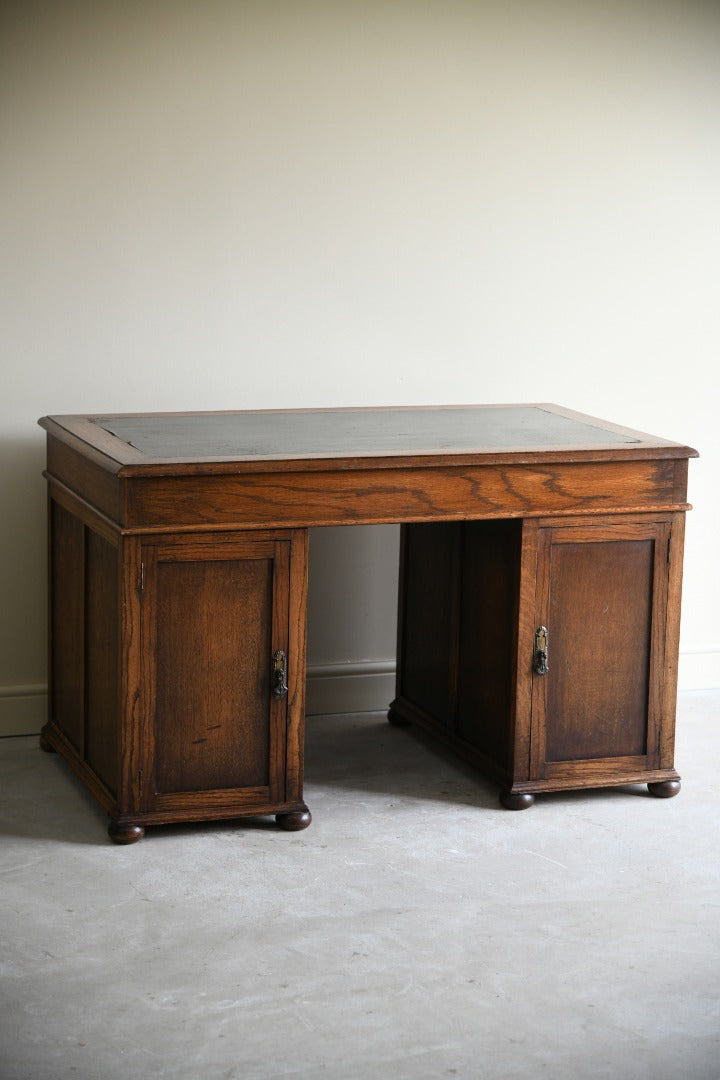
[0,691,720,1080]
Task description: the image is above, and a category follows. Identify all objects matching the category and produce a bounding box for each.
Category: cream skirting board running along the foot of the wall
[0,646,720,738]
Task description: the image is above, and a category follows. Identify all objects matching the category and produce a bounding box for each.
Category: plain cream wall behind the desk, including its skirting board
[0,0,720,731]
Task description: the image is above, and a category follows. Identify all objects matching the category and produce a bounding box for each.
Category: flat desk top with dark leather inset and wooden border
[40,404,696,474]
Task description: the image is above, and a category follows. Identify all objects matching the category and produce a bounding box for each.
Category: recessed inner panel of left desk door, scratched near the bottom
[155,558,273,792]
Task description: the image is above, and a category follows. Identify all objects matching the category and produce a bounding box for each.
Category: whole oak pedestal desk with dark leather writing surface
[40,405,696,843]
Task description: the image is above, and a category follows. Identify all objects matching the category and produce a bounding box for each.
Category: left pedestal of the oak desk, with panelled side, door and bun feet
[42,490,310,843]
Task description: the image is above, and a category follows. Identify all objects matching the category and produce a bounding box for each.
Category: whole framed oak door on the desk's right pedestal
[530,521,670,782]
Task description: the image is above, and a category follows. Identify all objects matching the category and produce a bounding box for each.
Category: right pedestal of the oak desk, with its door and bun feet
[391,513,684,809]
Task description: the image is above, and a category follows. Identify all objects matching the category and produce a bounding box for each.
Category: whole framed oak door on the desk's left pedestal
[134,534,293,812]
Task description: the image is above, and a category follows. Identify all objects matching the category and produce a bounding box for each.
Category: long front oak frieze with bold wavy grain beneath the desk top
[123,461,676,529]
